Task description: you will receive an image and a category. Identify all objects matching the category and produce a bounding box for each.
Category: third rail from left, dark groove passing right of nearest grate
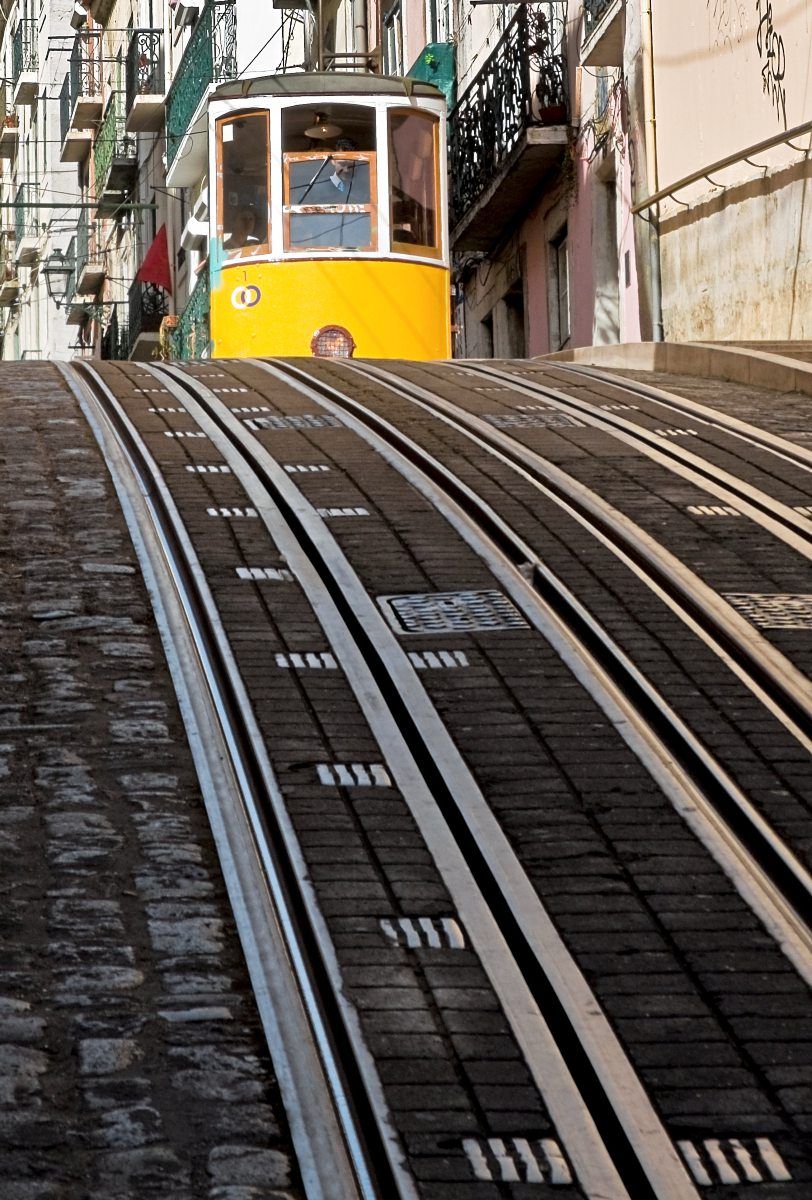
[266,364,812,955]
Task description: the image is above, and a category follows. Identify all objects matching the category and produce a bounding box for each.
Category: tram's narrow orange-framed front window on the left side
[217,113,269,258]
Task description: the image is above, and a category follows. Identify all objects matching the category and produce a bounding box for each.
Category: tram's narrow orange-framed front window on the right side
[389,109,440,257]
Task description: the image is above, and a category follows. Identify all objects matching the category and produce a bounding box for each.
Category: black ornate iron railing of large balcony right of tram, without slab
[449,0,567,227]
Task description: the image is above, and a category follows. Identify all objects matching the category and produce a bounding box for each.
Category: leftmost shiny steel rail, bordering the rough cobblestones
[60,364,400,1200]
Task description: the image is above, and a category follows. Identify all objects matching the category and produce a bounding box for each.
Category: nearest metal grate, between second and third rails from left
[378,592,528,634]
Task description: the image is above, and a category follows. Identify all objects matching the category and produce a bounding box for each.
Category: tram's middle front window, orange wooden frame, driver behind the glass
[282,104,378,252]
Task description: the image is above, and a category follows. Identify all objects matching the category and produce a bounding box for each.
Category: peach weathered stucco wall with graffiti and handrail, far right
[654,0,812,340]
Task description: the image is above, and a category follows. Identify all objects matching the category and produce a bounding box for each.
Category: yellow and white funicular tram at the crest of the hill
[203,72,451,359]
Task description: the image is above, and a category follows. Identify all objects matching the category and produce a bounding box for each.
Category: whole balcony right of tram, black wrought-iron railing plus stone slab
[449,0,569,250]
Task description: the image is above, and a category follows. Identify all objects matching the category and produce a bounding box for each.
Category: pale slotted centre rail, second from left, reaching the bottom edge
[151,362,696,1200]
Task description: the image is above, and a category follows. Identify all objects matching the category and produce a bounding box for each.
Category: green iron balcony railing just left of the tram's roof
[167,0,236,167]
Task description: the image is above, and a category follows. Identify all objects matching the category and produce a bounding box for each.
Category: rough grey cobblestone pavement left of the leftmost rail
[0,364,302,1200]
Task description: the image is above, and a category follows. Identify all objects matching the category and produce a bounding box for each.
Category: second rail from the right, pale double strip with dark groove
[462,362,812,544]
